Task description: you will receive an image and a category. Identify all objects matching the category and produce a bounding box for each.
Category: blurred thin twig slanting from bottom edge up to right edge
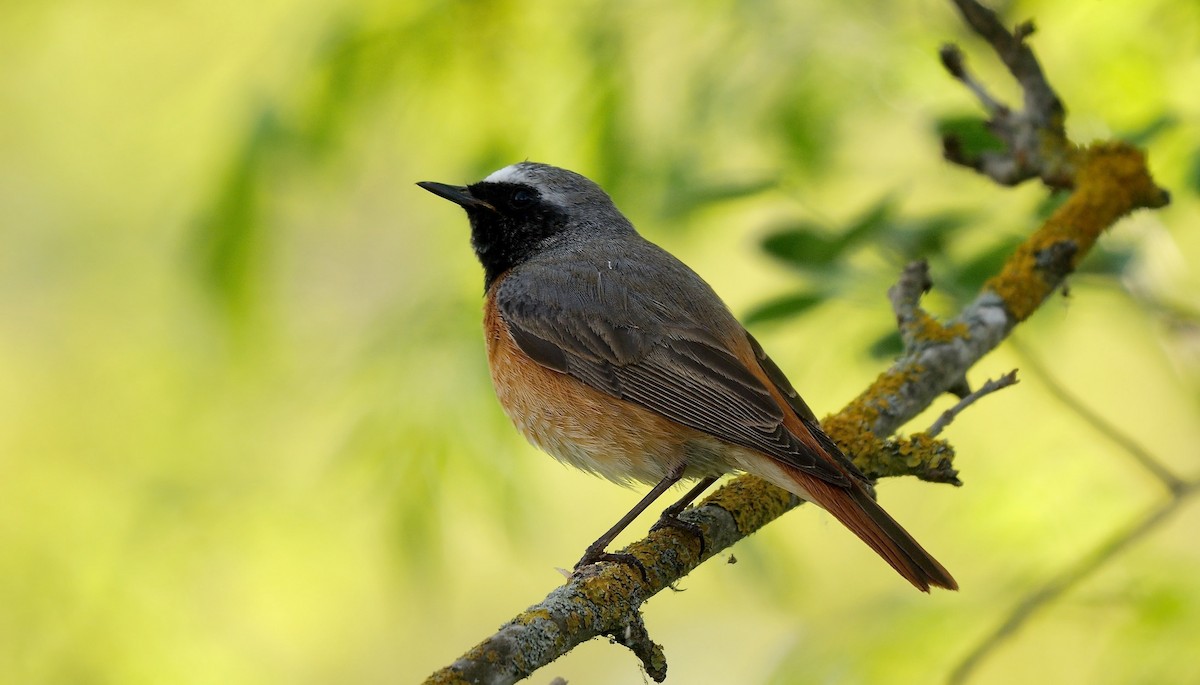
[947,479,1200,685]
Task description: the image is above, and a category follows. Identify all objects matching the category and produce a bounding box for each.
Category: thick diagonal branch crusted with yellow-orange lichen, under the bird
[426,0,1168,684]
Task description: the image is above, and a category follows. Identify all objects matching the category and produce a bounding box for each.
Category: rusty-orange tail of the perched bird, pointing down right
[793,473,959,593]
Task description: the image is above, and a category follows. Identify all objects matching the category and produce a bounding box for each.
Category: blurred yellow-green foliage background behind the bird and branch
[0,0,1200,685]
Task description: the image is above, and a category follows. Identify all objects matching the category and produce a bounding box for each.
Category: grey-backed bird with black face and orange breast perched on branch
[418,161,958,593]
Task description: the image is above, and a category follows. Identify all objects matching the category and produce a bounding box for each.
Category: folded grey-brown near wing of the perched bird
[497,256,856,487]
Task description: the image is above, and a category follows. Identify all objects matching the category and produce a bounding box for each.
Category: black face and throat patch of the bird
[467,181,568,288]
